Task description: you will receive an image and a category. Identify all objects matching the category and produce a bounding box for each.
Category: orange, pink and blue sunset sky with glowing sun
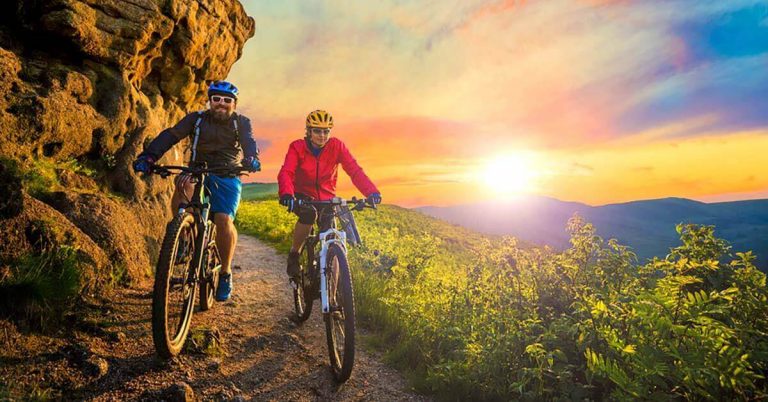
[228,0,768,206]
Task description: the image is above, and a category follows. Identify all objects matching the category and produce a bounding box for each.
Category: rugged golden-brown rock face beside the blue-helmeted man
[0,0,254,292]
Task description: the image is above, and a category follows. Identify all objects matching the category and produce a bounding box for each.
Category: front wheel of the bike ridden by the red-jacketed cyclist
[325,244,355,382]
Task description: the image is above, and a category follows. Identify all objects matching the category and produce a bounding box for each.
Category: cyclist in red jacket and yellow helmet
[277,110,381,279]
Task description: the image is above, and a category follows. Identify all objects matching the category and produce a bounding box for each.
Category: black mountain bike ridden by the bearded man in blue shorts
[151,163,255,358]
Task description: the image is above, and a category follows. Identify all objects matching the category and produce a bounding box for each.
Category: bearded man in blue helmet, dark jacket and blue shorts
[133,81,261,301]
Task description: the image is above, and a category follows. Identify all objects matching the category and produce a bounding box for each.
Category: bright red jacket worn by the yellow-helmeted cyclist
[277,137,379,201]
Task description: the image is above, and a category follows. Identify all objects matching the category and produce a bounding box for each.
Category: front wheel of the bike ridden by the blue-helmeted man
[152,213,197,358]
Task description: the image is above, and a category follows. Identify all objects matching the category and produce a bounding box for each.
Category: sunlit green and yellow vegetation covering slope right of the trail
[238,202,768,400]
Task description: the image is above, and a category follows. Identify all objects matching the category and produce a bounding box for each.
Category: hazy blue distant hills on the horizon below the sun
[417,196,768,271]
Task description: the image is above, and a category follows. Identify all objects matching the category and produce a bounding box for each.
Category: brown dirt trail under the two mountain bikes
[0,235,426,401]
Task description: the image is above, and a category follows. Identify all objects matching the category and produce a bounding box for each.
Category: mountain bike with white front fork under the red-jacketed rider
[291,197,376,382]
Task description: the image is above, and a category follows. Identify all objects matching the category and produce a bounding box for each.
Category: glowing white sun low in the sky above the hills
[480,152,539,195]
